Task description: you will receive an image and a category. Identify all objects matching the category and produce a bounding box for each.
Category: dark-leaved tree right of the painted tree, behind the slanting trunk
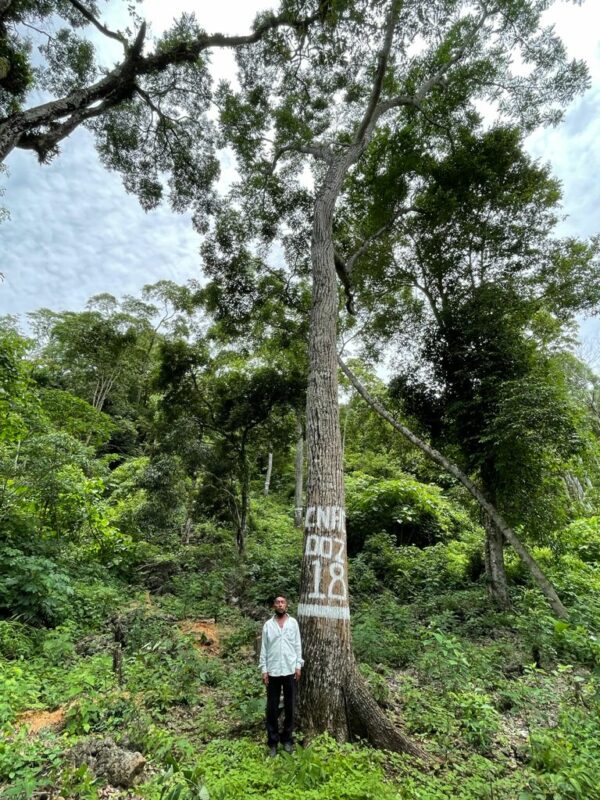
[346,126,600,606]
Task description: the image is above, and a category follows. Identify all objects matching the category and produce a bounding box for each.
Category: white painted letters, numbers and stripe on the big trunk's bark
[298,506,350,619]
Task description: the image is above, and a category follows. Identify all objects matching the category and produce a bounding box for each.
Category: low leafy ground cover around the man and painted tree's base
[0,499,600,800]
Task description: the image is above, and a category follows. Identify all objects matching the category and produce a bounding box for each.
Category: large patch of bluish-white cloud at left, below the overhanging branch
[0,130,200,314]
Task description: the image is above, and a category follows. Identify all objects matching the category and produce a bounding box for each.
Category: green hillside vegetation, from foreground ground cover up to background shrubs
[0,314,600,800]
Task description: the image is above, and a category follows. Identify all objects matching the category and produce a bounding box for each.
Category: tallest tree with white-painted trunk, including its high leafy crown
[221,0,586,753]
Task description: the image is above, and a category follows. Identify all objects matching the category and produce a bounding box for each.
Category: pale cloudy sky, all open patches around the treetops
[0,0,600,342]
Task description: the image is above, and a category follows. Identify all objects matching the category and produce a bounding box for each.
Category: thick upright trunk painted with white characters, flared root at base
[298,153,424,757]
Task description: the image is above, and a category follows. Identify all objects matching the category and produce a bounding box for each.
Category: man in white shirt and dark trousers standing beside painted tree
[258,597,304,756]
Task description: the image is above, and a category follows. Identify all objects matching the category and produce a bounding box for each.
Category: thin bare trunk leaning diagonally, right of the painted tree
[338,358,569,619]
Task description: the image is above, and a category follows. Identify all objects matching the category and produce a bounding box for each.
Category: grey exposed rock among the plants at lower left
[66,738,146,788]
